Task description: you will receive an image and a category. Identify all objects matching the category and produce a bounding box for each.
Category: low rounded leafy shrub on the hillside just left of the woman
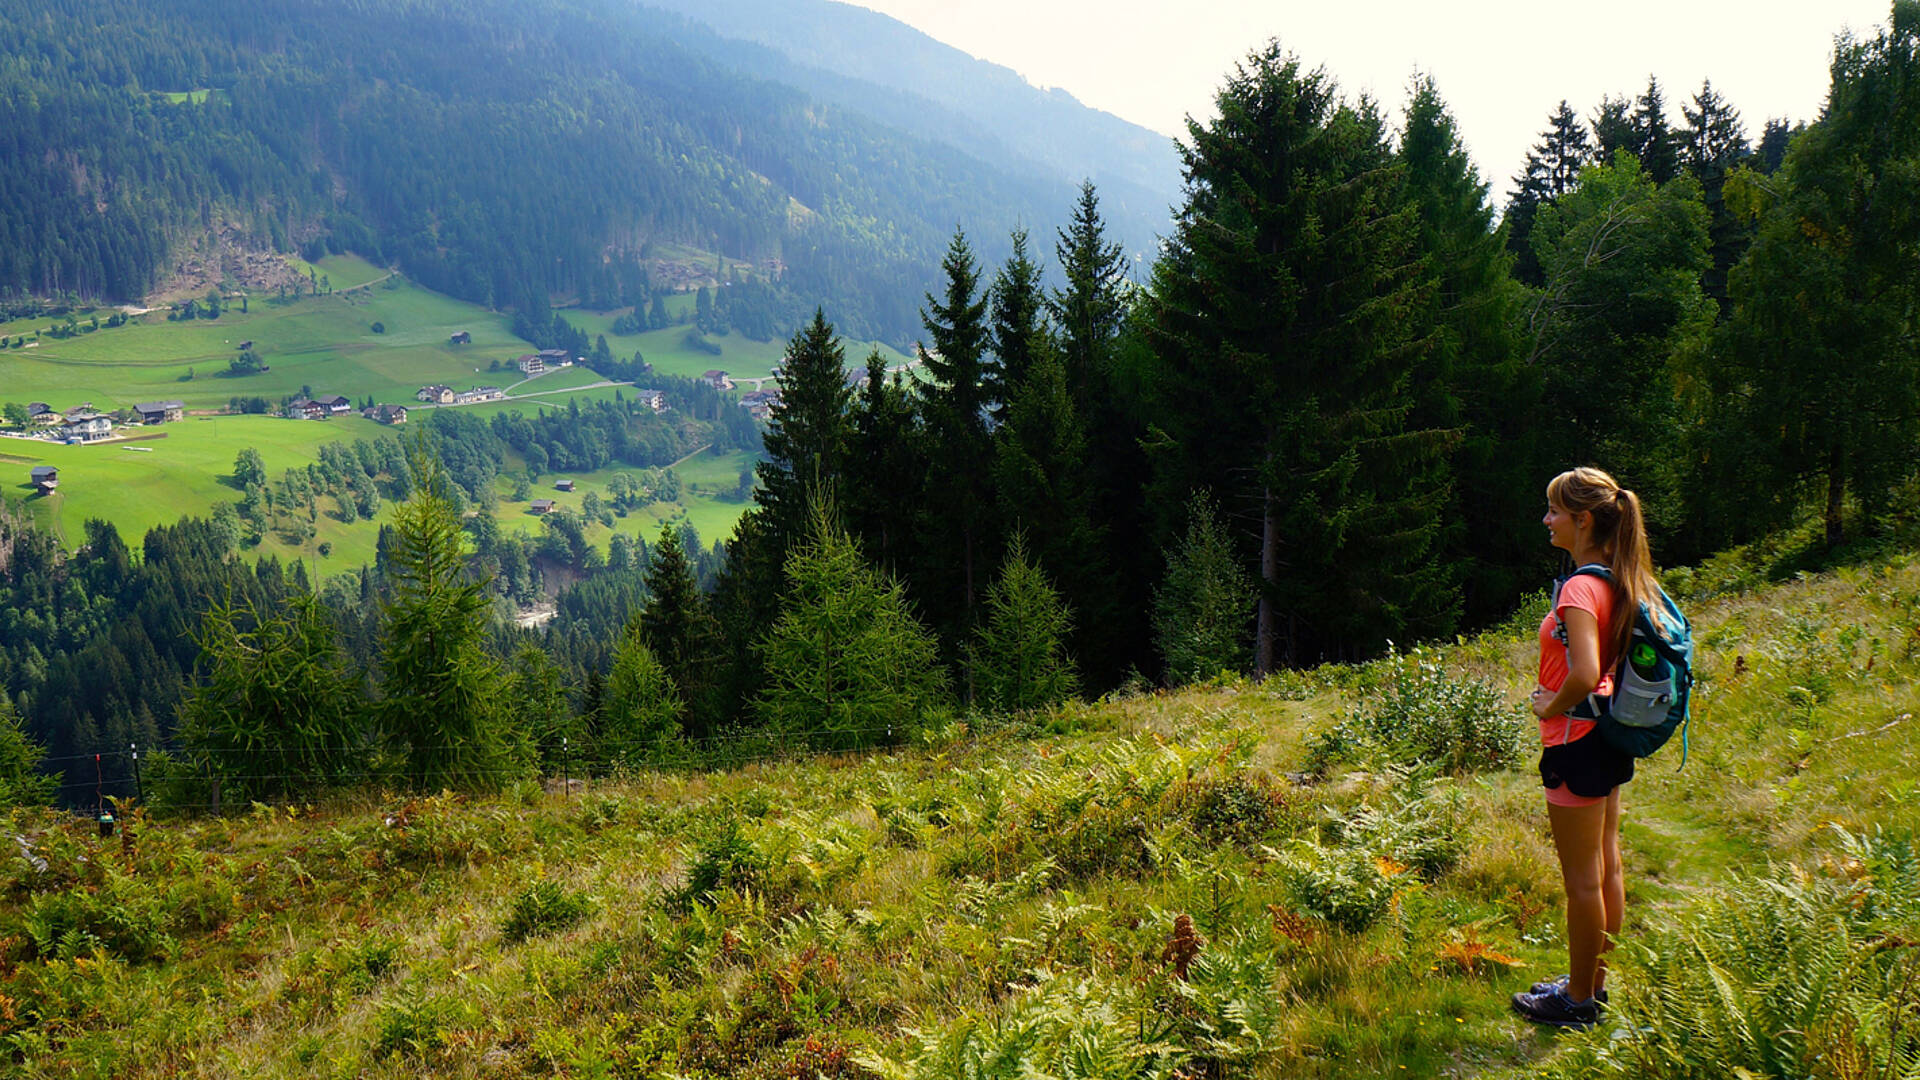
[1308,650,1526,773]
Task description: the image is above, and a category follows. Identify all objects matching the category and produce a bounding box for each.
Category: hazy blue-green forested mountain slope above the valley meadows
[0,0,1121,338]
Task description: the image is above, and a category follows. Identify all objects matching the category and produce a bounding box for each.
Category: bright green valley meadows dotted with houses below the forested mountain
[0,256,780,577]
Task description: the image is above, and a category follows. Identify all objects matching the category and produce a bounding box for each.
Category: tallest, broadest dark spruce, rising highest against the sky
[1150,44,1457,673]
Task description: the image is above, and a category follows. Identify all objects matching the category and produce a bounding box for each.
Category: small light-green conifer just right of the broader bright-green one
[968,532,1079,713]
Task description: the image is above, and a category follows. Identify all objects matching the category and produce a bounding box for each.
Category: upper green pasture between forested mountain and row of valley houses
[0,279,526,409]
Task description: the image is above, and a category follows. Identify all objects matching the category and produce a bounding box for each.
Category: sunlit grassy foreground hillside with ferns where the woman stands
[0,559,1920,1080]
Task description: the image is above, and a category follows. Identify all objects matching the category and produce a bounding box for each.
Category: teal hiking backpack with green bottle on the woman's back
[1551,563,1693,769]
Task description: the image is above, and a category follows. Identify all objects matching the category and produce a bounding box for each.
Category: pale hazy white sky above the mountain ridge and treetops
[852,0,1893,192]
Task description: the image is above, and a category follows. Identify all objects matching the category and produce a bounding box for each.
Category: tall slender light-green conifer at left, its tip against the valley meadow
[378,446,532,790]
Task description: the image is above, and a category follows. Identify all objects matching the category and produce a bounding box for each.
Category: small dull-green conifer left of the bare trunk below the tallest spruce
[1154,492,1254,686]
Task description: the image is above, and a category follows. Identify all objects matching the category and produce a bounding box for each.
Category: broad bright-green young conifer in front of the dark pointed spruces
[755,500,947,749]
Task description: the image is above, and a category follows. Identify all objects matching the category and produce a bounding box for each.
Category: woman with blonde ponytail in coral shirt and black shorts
[1513,469,1659,1026]
